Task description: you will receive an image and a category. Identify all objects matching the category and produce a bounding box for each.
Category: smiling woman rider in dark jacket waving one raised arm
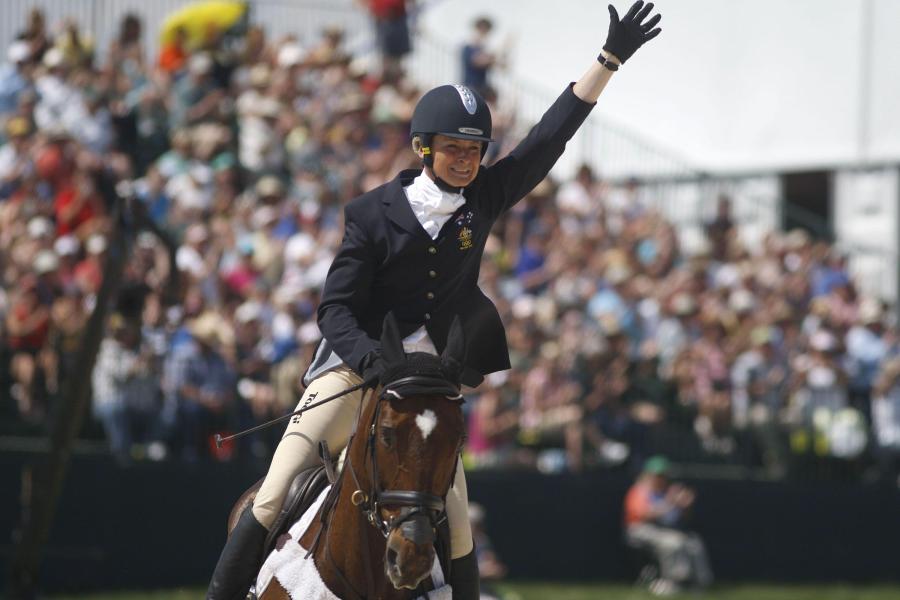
[207,1,660,600]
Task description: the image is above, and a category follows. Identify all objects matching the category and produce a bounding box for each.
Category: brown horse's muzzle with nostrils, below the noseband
[384,515,434,590]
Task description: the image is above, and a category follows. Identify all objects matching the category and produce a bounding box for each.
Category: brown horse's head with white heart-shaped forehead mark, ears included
[357,314,465,589]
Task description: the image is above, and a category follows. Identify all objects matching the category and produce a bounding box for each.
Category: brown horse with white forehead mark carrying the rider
[251,316,465,600]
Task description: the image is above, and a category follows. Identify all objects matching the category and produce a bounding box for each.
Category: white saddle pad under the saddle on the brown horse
[256,486,453,600]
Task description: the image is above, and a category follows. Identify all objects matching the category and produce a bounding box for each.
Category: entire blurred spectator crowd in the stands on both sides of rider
[0,10,900,479]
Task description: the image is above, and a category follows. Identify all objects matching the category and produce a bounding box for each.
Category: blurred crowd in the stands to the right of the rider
[470,190,900,486]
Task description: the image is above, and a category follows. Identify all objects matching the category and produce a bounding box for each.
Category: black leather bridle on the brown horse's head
[347,375,463,538]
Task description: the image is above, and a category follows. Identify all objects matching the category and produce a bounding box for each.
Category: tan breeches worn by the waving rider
[246,367,472,558]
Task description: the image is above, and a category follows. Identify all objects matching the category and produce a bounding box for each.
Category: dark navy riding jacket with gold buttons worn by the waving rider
[311,85,594,386]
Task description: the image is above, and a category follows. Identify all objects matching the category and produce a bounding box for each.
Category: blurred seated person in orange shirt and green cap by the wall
[625,456,712,595]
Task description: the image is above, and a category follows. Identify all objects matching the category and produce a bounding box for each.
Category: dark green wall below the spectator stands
[0,454,900,591]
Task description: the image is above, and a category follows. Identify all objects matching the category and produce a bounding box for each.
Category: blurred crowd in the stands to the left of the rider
[0,9,432,461]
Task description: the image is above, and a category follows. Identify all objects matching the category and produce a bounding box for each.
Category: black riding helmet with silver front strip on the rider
[410,84,494,167]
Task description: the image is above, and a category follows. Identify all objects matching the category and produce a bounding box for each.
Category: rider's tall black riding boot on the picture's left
[206,507,269,600]
